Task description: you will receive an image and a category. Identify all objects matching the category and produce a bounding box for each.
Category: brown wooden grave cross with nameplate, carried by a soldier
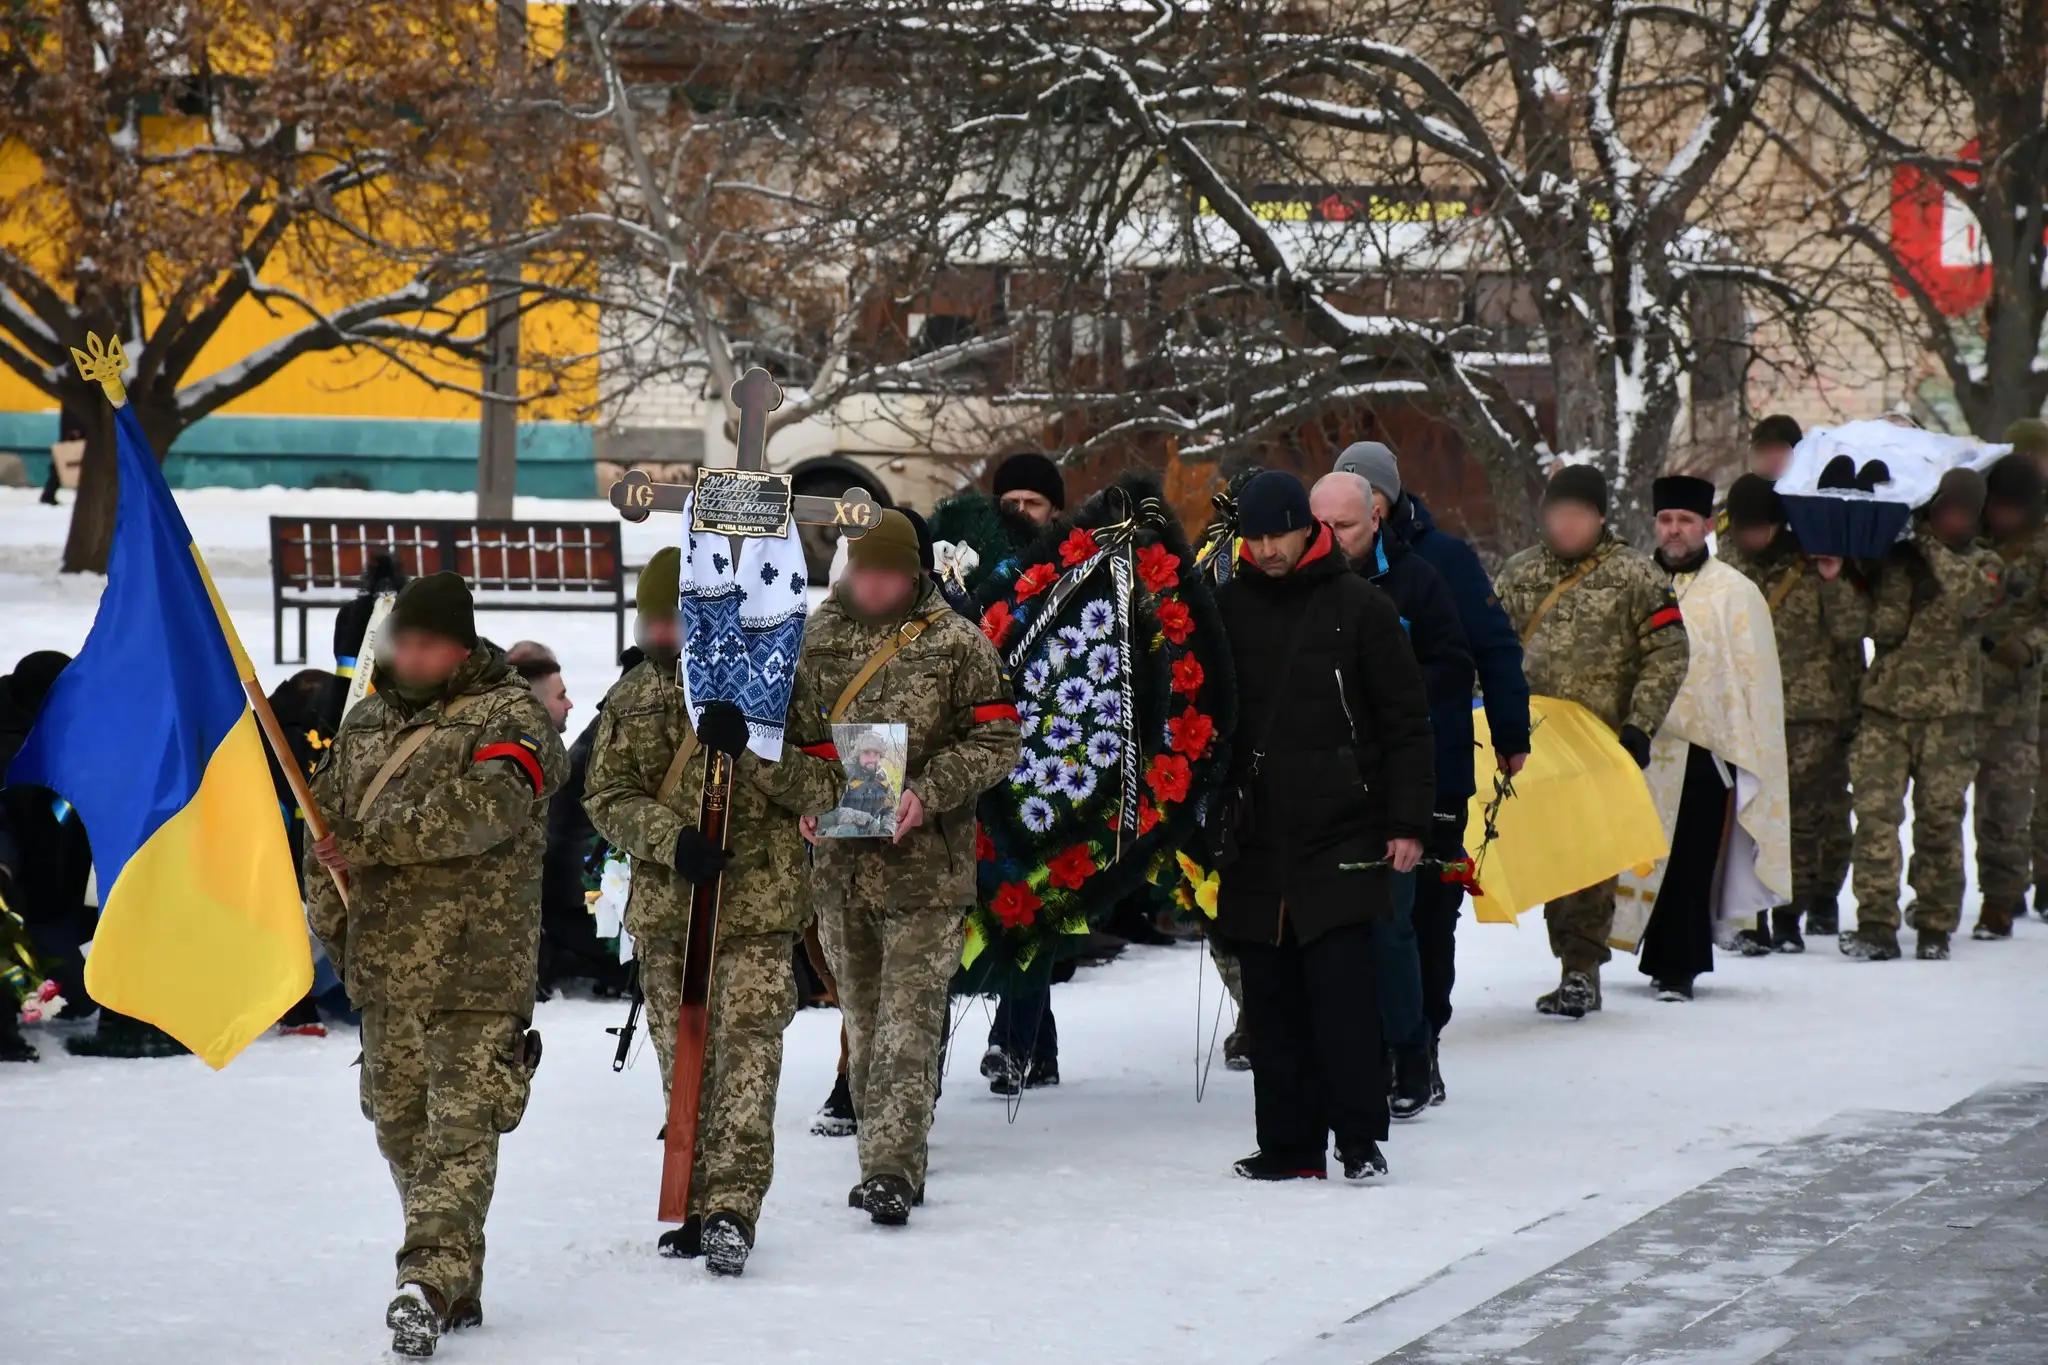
[610,366,883,1224]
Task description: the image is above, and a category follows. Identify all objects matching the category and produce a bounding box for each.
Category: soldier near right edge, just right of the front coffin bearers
[1970,454,2048,939]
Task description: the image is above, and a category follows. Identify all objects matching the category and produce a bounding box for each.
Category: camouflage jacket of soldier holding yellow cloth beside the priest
[1495,534,1690,735]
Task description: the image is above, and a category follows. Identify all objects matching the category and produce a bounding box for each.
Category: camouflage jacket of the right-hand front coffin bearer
[1864,526,2003,720]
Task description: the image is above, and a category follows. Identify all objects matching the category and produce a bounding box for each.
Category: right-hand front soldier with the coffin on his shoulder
[1837,469,1999,962]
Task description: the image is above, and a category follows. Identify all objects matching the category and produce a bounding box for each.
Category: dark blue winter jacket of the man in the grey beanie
[1389,493,1530,810]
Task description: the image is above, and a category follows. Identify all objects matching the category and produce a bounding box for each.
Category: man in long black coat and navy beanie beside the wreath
[1217,471,1434,1181]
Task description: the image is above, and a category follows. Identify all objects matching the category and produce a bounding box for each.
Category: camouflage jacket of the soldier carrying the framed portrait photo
[791,577,1022,909]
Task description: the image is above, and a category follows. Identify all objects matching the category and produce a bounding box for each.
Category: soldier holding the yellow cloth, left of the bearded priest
[1495,465,1690,1019]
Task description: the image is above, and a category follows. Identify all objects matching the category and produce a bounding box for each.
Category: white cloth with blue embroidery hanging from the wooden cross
[678,493,809,763]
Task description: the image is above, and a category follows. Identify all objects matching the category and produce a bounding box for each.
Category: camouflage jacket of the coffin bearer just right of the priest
[1724,532,1870,724]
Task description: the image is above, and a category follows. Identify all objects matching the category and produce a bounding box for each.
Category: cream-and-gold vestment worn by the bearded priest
[1612,559,1792,950]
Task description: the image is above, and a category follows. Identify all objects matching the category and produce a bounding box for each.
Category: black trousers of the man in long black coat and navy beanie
[1231,925,1386,1166]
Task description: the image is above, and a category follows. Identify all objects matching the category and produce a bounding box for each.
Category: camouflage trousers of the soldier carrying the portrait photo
[817,905,967,1189]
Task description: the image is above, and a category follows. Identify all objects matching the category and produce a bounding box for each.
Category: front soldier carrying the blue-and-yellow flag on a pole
[305,573,569,1355]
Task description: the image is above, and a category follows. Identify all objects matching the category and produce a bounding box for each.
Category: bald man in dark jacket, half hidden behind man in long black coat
[1309,471,1473,1119]
